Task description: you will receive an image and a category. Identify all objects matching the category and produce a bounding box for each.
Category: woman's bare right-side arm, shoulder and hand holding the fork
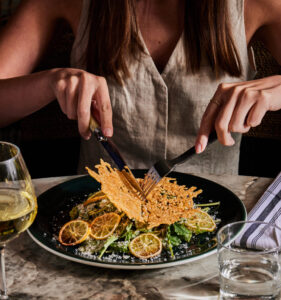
[196,0,281,153]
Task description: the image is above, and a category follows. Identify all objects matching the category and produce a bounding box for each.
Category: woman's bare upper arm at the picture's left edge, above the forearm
[0,0,61,78]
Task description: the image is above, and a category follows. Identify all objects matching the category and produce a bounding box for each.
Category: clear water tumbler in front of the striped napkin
[217,221,281,300]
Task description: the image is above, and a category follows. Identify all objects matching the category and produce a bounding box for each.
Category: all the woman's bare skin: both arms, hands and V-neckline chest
[0,0,281,148]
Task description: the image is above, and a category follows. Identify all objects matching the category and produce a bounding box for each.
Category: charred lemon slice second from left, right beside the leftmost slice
[90,213,121,240]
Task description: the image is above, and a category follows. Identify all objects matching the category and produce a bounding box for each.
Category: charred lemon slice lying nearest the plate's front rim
[129,233,162,259]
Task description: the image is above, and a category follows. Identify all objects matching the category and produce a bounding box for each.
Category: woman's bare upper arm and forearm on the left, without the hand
[0,0,58,127]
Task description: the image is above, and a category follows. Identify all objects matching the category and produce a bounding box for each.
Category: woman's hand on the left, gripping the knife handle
[51,68,113,140]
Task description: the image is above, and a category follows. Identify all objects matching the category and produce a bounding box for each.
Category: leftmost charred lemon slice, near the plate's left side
[59,220,90,246]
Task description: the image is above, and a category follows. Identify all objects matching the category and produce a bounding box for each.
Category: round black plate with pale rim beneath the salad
[28,170,244,269]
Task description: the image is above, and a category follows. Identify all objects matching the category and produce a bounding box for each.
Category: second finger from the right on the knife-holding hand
[77,74,95,140]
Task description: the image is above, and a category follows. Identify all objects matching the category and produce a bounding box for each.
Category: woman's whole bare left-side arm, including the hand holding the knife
[0,0,112,138]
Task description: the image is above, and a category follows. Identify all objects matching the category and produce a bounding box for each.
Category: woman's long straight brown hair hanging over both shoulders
[85,0,242,84]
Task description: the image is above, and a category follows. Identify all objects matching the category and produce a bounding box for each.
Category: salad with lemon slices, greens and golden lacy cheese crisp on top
[58,161,219,260]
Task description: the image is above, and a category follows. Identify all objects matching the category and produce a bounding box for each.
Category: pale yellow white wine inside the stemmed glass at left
[0,189,37,246]
